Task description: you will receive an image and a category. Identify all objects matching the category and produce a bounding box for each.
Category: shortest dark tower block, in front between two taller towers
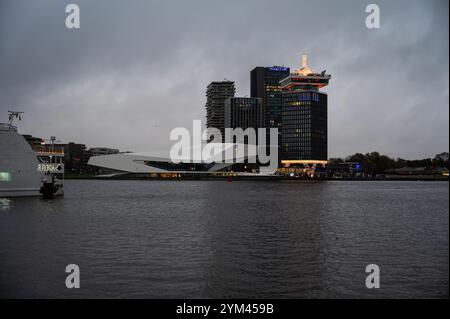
[225,97,263,138]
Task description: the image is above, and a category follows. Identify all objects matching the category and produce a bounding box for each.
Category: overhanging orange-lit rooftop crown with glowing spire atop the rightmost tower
[280,53,331,91]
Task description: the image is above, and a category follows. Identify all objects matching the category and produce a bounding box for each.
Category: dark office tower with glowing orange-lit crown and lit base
[280,54,331,167]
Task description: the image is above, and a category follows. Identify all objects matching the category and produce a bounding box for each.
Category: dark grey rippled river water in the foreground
[0,180,449,298]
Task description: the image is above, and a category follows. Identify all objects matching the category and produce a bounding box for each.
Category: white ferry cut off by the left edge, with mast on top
[0,111,64,198]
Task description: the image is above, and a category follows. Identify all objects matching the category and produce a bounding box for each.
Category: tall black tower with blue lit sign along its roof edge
[250,66,289,159]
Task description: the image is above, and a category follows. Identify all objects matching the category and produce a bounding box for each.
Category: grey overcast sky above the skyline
[0,0,449,158]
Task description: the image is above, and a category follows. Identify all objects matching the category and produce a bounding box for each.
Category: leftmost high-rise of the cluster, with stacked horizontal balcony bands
[205,81,236,140]
